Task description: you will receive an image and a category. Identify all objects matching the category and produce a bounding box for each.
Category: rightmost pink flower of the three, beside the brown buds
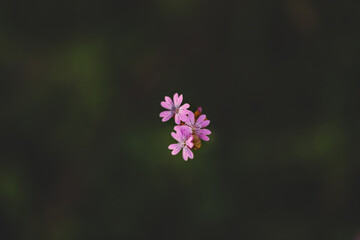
[174,111,211,141]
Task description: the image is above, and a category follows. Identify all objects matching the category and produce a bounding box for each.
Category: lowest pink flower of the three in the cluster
[169,126,194,161]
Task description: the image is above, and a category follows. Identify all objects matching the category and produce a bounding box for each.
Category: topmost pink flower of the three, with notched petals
[160,93,190,124]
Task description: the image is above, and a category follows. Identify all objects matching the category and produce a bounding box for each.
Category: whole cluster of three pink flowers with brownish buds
[160,93,211,161]
